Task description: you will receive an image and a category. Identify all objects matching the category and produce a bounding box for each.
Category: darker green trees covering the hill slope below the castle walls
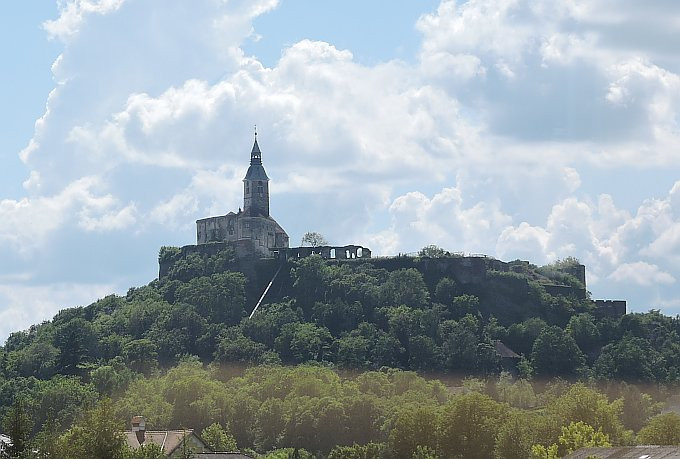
[0,251,680,386]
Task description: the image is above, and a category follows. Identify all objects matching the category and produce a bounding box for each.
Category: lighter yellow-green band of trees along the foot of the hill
[5,359,680,459]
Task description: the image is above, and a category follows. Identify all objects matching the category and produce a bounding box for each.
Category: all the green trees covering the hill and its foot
[0,248,680,459]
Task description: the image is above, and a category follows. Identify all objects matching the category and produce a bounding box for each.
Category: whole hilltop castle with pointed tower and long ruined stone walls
[158,133,626,317]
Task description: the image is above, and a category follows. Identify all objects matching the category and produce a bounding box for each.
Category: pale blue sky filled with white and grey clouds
[0,0,680,341]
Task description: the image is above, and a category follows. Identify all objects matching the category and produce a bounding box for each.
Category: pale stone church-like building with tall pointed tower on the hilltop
[196,133,288,257]
